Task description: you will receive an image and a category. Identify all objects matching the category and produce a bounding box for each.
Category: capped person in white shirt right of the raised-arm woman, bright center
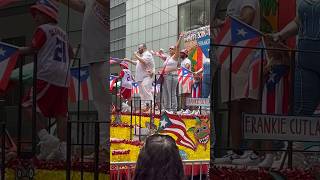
[179,49,191,114]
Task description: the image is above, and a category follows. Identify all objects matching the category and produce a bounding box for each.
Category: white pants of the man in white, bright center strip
[138,77,153,107]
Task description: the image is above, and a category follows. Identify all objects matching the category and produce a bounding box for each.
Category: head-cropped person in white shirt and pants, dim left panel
[59,0,111,162]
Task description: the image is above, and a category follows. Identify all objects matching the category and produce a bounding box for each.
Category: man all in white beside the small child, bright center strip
[125,44,155,112]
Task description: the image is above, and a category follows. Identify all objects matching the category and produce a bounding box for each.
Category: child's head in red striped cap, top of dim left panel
[30,0,58,25]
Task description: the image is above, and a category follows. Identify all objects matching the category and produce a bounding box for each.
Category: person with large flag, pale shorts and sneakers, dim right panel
[214,0,261,165]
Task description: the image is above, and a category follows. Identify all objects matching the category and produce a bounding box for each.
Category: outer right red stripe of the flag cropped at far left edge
[0,53,19,90]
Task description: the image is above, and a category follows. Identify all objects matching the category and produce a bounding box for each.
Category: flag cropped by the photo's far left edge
[0,42,19,91]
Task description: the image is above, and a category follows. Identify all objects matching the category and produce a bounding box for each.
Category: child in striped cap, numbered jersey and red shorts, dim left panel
[20,0,72,160]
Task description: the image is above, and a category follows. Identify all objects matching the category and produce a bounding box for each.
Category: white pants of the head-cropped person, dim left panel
[89,62,111,148]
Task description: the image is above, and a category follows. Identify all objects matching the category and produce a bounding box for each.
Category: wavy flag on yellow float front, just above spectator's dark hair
[158,112,195,151]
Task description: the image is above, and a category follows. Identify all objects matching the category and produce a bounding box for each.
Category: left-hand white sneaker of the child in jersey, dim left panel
[37,134,59,160]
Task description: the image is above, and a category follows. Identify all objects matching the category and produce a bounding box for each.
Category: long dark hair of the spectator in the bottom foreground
[133,134,185,180]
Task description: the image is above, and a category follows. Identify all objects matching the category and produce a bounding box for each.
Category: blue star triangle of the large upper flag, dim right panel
[231,17,261,44]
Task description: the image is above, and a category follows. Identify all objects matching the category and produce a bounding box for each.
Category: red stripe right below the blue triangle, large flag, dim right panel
[232,38,260,73]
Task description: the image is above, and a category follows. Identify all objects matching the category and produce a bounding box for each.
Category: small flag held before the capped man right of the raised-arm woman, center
[178,67,193,93]
